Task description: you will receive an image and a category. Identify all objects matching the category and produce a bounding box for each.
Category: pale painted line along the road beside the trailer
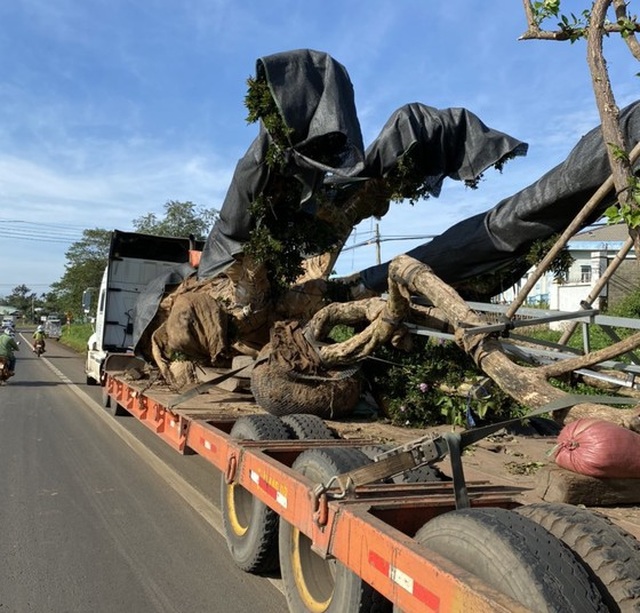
[40,357,285,594]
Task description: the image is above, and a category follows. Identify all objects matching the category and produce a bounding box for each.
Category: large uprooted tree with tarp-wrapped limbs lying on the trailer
[134,1,640,428]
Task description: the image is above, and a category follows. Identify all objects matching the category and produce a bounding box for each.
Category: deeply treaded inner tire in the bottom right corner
[516,502,640,612]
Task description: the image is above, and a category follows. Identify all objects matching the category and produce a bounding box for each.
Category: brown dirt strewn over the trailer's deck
[112,360,640,539]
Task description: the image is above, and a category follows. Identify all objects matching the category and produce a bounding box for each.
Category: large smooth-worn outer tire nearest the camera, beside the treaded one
[398,508,608,613]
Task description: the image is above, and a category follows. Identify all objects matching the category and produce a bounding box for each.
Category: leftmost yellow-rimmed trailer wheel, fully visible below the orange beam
[220,415,290,573]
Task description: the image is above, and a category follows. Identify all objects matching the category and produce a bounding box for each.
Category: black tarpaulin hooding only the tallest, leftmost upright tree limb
[198,49,364,278]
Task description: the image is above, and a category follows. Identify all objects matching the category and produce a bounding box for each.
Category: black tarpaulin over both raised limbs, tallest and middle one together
[198,49,527,279]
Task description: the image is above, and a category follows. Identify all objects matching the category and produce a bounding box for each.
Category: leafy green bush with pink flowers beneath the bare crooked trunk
[367,337,524,427]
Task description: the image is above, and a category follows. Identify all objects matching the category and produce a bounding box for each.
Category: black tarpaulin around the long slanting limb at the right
[360,102,640,298]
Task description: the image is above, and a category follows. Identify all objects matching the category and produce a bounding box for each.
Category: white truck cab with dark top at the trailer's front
[83,230,200,385]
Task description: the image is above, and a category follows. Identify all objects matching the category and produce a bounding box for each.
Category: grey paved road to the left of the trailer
[0,332,287,613]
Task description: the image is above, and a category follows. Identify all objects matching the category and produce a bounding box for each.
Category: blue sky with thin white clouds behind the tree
[0,0,638,296]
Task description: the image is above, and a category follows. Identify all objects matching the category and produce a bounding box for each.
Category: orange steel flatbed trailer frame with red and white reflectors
[102,354,632,613]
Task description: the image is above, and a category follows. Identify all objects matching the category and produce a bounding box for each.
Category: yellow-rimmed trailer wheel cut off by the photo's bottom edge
[280,447,391,613]
